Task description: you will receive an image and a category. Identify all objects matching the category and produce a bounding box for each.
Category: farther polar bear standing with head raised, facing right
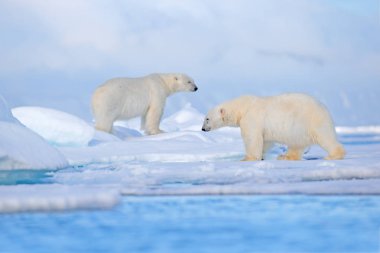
[92,74,198,135]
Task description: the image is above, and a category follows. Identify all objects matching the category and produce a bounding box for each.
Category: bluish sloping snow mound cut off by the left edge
[0,99,68,170]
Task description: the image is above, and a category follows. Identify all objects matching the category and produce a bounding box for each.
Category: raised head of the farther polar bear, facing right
[161,74,198,93]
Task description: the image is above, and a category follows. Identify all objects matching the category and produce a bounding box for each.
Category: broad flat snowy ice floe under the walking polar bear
[54,105,380,198]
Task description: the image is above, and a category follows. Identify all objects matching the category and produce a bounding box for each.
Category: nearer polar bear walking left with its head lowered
[202,93,345,161]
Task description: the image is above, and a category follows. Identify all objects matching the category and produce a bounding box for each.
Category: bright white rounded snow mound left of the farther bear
[12,107,95,147]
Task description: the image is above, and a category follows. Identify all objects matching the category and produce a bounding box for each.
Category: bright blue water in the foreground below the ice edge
[0,195,380,253]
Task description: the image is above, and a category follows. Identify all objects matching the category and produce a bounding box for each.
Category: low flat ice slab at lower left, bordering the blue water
[0,184,120,213]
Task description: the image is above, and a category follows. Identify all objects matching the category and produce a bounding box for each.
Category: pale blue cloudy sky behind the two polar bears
[0,0,380,125]
